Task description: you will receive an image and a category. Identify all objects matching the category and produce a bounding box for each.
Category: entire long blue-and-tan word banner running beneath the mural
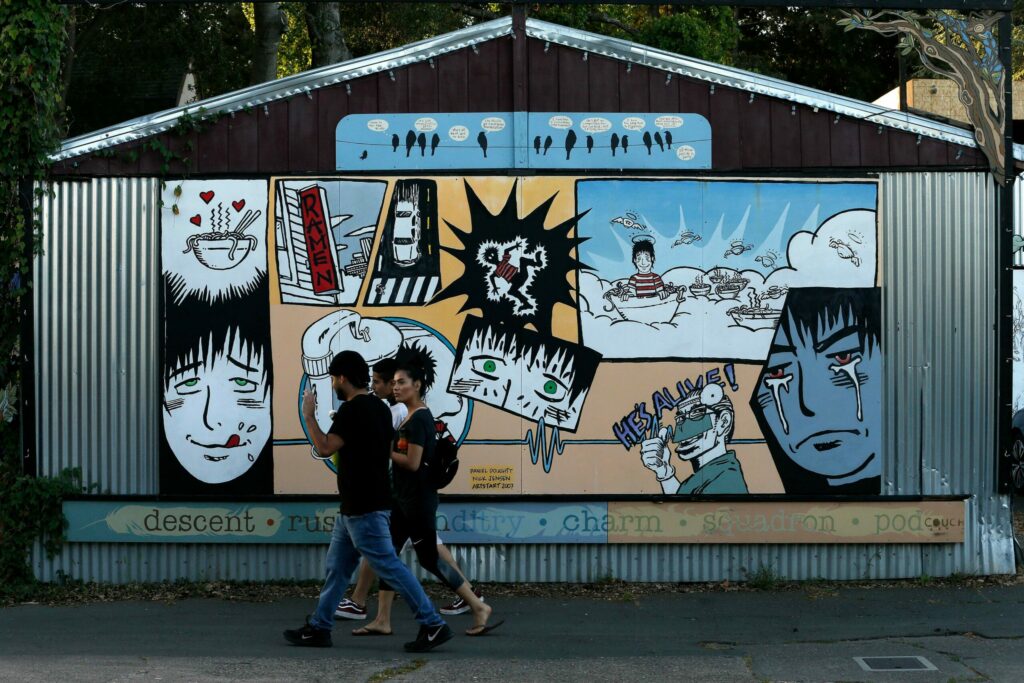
[63,501,965,544]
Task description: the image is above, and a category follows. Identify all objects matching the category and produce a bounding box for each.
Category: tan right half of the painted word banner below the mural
[603,501,965,544]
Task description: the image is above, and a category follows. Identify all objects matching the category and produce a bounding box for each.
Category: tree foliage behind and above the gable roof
[59,0,917,133]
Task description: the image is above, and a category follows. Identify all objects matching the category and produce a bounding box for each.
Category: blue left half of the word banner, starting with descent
[63,501,608,544]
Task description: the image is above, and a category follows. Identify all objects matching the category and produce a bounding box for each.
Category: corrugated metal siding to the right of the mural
[880,173,1014,577]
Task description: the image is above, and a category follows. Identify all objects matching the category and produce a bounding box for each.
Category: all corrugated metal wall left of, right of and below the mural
[34,173,1014,583]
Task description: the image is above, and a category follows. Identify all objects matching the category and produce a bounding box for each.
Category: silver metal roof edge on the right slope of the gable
[526,18,1024,160]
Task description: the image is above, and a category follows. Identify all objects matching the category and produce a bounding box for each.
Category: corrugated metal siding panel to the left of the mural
[35,178,160,495]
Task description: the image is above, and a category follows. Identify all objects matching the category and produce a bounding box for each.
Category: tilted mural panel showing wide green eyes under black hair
[449,317,600,430]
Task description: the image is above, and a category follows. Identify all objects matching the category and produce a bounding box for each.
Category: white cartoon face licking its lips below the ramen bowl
[163,331,270,483]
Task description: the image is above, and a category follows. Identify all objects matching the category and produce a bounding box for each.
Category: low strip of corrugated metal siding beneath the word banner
[25,544,991,584]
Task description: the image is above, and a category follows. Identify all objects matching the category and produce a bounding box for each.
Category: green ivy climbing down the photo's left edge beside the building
[0,0,81,592]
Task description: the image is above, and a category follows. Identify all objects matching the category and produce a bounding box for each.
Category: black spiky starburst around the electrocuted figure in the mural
[433,181,592,337]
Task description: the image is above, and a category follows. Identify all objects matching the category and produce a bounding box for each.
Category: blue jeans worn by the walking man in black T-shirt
[309,510,444,631]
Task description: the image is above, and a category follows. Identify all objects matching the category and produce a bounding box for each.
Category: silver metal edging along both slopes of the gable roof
[50,16,1024,161]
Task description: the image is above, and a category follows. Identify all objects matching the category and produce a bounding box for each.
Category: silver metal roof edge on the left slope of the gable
[49,16,512,162]
